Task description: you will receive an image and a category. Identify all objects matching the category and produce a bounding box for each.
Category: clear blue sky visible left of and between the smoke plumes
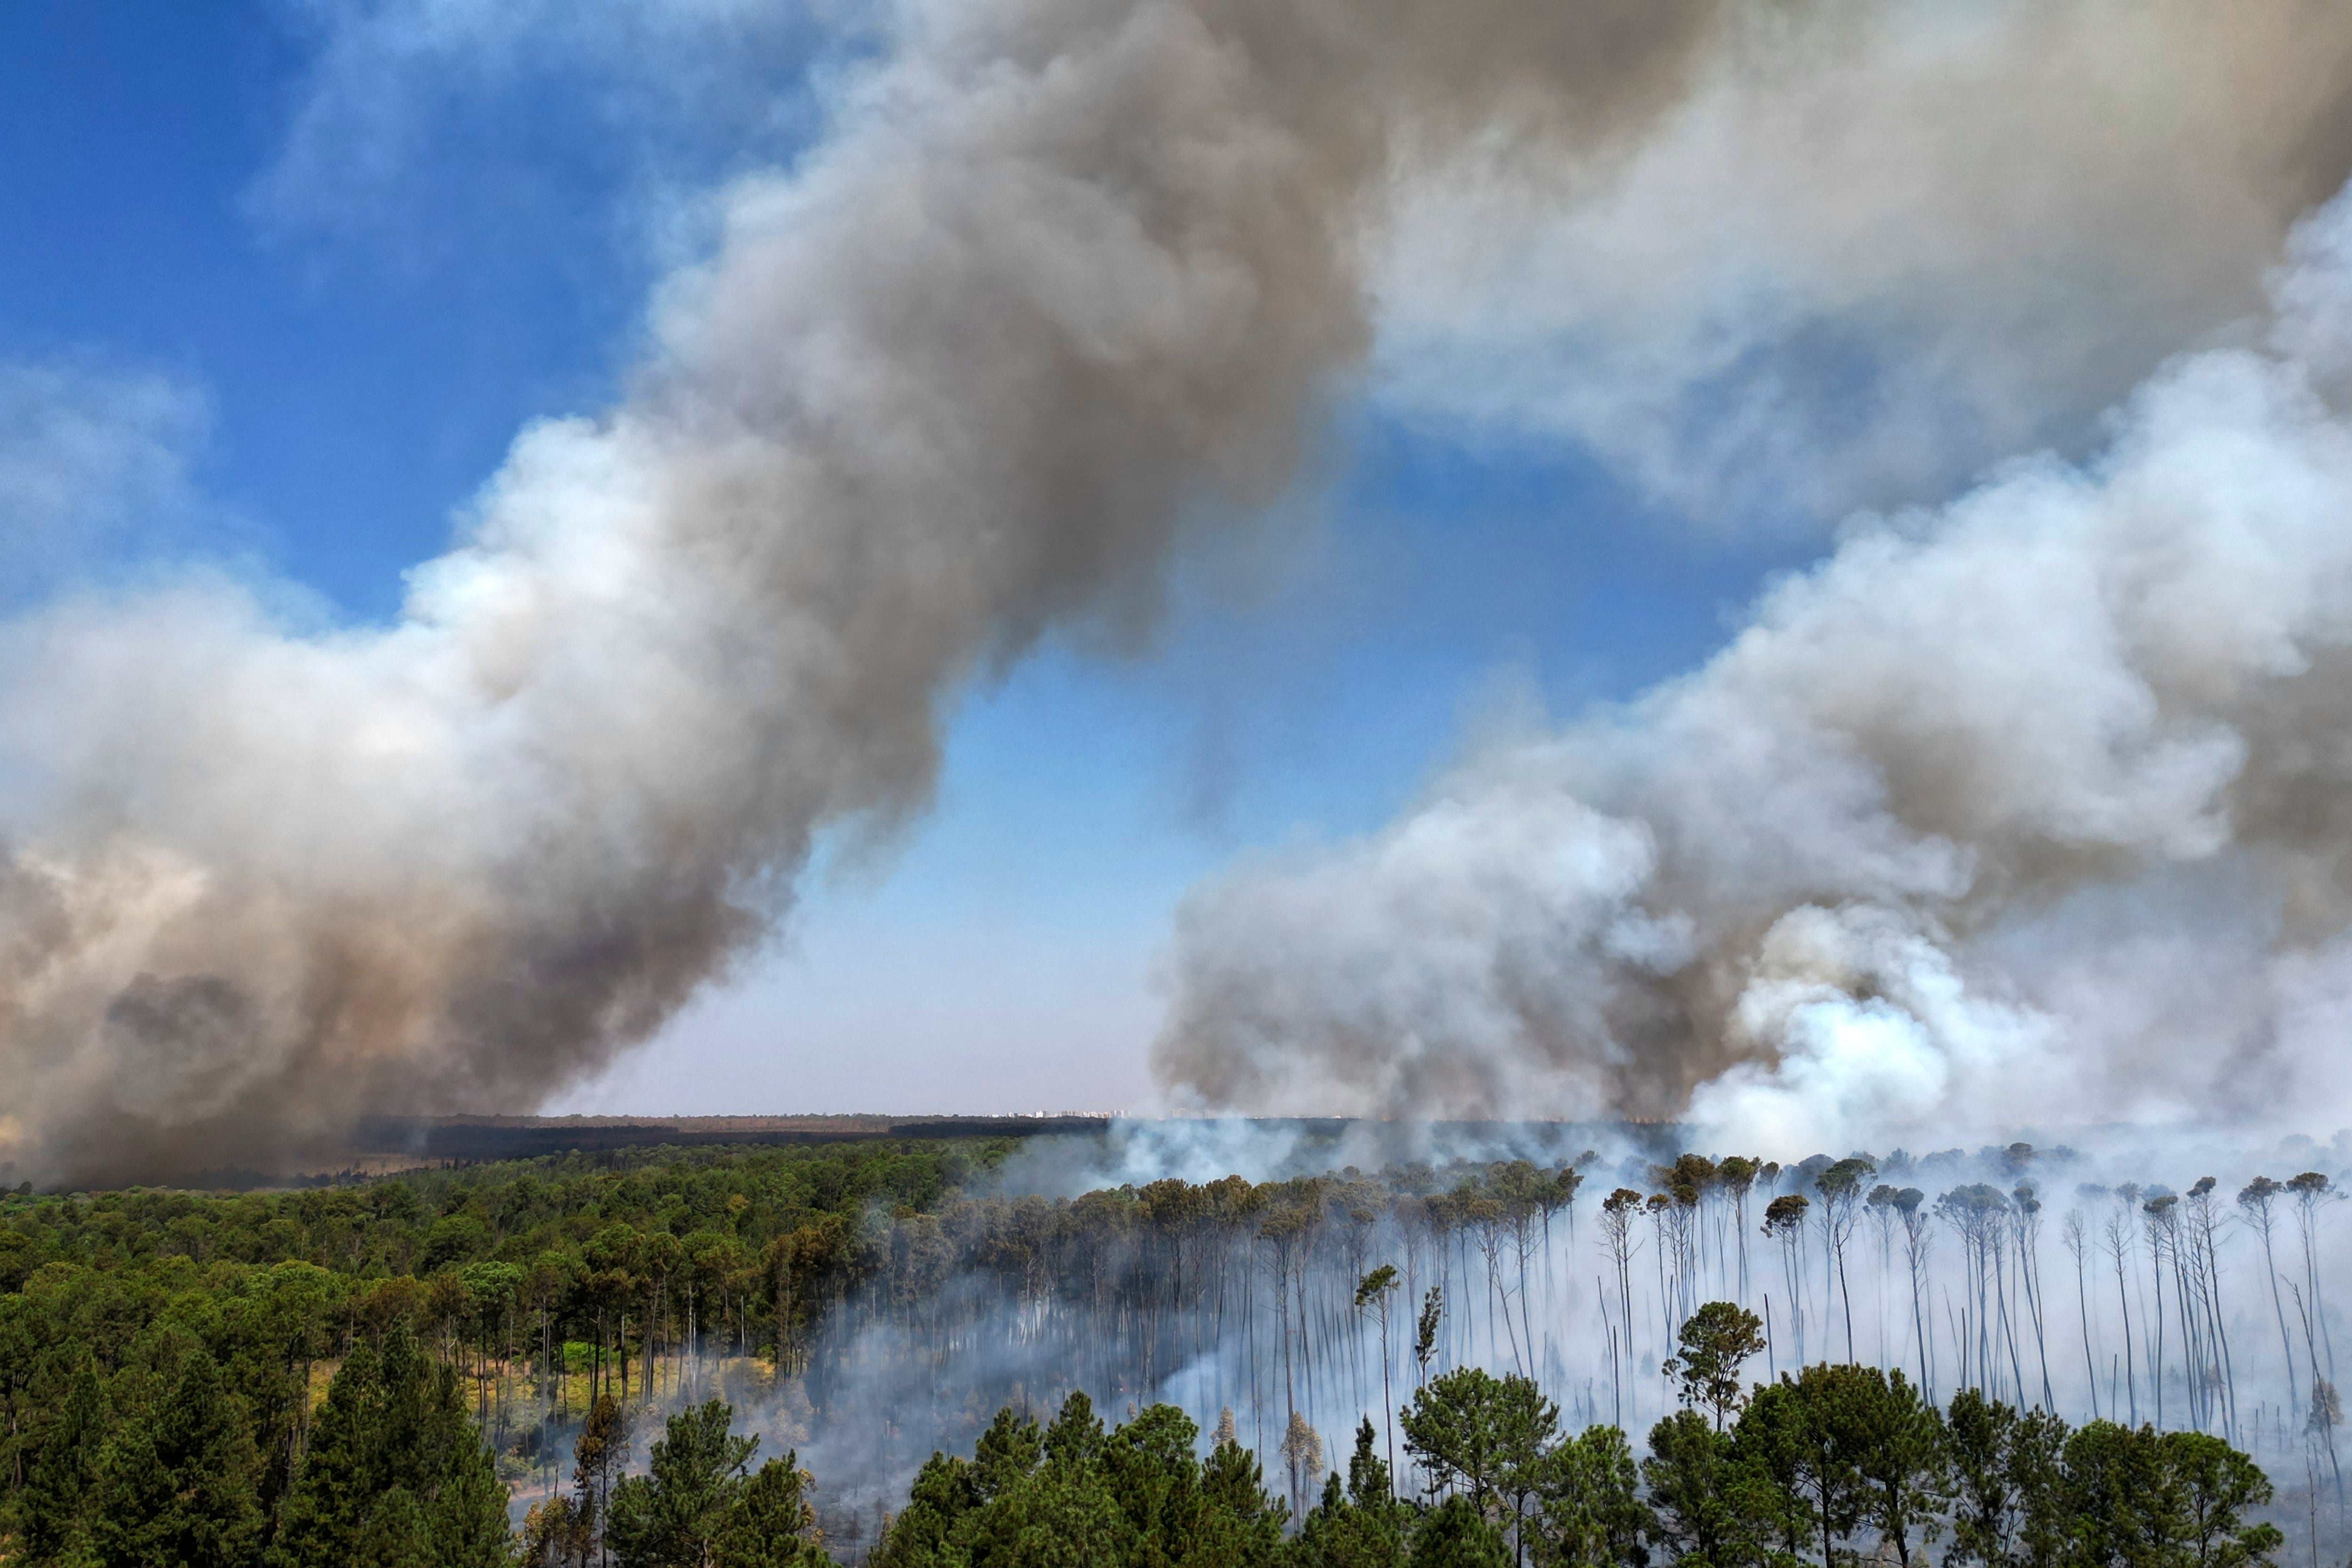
[0,0,1797,1112]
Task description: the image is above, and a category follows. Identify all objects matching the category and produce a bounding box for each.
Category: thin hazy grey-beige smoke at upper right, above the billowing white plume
[1374,0,2352,529]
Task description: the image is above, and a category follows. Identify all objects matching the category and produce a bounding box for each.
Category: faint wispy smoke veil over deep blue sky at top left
[245,0,833,248]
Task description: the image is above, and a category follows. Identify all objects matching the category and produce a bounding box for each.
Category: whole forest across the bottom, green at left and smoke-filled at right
[0,1140,2345,1568]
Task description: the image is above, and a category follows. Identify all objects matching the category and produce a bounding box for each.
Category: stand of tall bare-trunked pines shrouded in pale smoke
[663,1145,2340,1542]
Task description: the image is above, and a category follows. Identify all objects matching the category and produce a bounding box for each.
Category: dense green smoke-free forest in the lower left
[0,1140,1011,1568]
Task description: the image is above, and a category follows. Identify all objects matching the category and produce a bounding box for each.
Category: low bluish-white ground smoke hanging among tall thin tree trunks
[597,1119,2352,1561]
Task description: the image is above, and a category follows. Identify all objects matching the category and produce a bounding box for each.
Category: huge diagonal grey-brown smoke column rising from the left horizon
[0,0,1750,1173]
